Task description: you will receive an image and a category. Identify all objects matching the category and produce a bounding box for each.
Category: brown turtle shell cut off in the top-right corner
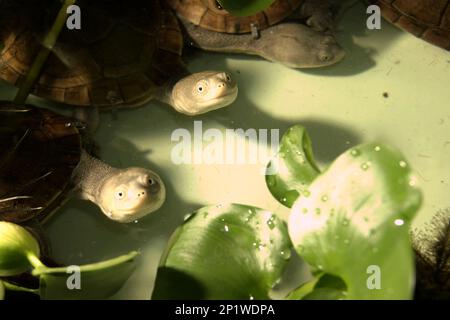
[376,0,450,50]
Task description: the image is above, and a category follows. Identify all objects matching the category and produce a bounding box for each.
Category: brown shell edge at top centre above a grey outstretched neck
[167,0,304,33]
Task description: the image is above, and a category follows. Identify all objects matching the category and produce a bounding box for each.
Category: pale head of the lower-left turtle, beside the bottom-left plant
[96,167,166,223]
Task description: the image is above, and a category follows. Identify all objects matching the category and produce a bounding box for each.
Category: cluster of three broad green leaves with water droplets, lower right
[153,126,422,299]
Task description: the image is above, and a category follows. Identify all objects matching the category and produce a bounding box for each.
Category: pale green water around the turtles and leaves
[0,5,450,299]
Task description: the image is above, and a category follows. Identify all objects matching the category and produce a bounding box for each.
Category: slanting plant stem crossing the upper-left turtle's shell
[14,0,76,104]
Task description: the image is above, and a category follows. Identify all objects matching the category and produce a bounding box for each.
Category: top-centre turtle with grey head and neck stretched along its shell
[167,0,345,68]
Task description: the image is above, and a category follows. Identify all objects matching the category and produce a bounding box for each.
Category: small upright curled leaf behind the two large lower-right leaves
[266,125,320,208]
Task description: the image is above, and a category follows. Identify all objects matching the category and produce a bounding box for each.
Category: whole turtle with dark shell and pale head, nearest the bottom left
[0,101,165,223]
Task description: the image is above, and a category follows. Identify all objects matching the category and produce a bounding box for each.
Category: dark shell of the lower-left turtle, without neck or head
[0,101,81,223]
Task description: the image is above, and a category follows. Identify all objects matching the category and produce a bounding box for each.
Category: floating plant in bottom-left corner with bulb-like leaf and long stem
[0,221,138,299]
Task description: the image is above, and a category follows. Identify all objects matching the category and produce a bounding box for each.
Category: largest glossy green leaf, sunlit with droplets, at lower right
[288,144,421,299]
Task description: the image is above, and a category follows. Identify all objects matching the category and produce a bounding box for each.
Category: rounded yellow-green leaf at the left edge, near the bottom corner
[0,221,41,277]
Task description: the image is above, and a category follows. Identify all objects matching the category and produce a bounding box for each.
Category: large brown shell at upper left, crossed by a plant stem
[0,0,184,107]
